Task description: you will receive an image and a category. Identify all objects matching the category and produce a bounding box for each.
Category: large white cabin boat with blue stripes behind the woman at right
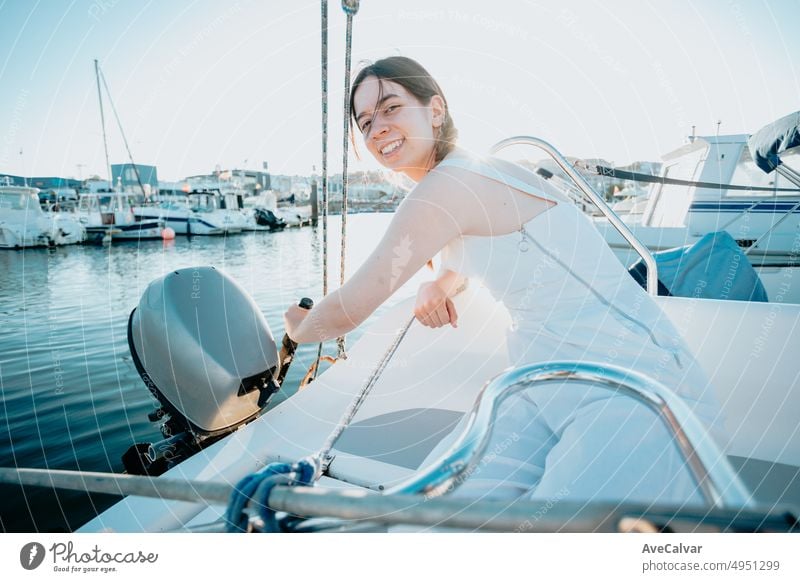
[580,114,800,303]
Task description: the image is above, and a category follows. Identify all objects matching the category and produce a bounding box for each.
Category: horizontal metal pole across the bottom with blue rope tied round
[0,468,780,532]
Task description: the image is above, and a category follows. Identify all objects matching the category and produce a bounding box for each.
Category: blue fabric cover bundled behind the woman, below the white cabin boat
[630,231,767,301]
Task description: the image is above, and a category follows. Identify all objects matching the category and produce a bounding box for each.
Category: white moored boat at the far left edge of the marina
[0,186,86,249]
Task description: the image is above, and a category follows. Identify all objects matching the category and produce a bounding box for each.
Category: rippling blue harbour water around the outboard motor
[0,214,432,532]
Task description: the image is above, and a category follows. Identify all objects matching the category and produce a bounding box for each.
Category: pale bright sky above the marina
[0,0,800,180]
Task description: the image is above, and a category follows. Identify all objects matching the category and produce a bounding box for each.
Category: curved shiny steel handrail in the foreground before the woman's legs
[386,362,754,508]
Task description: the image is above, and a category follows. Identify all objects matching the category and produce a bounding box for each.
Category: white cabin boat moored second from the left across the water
[77,191,165,243]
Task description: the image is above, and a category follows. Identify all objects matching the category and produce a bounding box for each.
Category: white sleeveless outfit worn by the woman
[429,158,725,504]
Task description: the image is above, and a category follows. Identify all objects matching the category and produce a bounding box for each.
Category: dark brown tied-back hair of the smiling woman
[350,57,458,164]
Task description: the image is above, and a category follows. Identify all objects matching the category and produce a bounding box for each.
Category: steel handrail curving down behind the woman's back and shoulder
[490,135,658,295]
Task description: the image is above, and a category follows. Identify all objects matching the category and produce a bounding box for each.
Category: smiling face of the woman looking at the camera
[353,77,444,182]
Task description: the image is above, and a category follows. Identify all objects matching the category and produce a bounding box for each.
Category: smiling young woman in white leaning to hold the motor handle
[285,57,722,503]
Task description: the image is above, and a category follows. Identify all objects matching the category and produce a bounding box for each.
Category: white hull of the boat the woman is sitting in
[80,288,800,531]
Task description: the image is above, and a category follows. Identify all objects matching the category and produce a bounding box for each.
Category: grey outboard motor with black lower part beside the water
[123,267,302,475]
